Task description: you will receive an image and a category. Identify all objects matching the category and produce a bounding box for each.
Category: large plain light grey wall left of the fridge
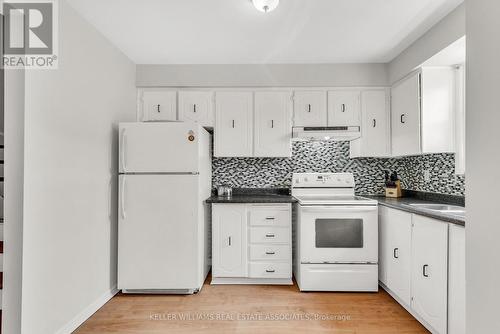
[18,1,136,334]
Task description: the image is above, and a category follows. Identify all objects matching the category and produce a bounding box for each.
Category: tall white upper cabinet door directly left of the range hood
[254,92,292,157]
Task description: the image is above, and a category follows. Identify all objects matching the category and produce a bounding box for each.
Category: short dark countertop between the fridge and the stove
[206,188,297,204]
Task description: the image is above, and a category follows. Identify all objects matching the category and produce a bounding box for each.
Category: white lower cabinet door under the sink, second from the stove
[411,215,448,334]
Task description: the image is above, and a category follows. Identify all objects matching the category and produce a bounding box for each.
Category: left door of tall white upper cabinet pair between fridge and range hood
[214,92,253,157]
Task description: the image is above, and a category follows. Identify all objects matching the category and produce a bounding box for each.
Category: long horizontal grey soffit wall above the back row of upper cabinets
[137,64,389,87]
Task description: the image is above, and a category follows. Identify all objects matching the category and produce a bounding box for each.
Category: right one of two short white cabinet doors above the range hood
[328,90,361,126]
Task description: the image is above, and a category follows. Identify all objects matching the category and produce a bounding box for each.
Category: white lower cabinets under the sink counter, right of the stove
[379,207,465,334]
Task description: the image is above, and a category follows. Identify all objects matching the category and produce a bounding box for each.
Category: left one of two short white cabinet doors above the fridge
[140,90,177,121]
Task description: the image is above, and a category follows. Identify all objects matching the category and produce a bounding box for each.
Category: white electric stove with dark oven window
[292,173,378,291]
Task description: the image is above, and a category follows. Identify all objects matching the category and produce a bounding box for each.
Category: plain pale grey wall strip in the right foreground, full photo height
[466,0,500,334]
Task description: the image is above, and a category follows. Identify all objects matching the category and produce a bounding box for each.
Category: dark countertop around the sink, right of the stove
[364,196,465,226]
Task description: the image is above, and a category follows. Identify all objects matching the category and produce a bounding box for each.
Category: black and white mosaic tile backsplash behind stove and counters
[212,141,465,196]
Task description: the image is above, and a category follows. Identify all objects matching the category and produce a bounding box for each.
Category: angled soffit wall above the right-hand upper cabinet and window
[388,4,465,83]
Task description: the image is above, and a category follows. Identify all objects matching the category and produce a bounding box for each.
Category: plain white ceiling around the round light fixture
[68,0,463,64]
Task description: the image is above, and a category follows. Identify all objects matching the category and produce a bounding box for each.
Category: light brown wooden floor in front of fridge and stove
[75,276,428,334]
